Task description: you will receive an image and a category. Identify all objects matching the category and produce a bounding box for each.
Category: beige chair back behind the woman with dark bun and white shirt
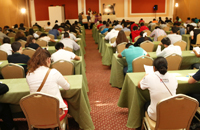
[155,94,199,130]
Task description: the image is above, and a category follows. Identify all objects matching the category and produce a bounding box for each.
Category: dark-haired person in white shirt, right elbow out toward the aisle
[51,42,80,62]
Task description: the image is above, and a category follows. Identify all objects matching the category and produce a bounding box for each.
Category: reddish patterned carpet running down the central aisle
[16,30,133,130]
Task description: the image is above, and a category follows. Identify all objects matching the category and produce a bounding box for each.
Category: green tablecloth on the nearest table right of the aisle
[118,70,200,128]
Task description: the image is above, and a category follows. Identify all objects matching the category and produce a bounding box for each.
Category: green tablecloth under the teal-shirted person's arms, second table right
[110,51,200,88]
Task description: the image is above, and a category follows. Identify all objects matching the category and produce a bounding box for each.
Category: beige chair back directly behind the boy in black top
[1,63,25,79]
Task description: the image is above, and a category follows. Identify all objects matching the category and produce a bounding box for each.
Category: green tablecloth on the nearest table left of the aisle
[0,75,94,130]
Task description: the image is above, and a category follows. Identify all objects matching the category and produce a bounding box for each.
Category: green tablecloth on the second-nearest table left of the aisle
[0,56,89,92]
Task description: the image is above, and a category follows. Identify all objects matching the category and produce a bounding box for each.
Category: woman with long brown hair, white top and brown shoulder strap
[26,48,70,118]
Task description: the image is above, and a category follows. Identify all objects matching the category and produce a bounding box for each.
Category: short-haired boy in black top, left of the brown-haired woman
[7,41,30,73]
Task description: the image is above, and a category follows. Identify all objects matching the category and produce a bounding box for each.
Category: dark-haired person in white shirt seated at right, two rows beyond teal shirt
[167,27,182,44]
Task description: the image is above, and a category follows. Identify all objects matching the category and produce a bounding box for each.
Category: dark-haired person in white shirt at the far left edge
[0,37,12,55]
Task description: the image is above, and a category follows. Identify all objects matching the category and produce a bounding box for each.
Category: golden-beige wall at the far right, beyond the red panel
[174,0,200,21]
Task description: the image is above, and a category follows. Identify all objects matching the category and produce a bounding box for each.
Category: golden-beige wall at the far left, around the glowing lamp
[0,0,27,27]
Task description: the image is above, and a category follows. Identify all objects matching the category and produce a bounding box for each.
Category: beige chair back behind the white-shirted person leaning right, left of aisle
[51,60,74,75]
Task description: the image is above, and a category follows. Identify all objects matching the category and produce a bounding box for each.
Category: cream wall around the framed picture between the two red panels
[100,0,124,17]
